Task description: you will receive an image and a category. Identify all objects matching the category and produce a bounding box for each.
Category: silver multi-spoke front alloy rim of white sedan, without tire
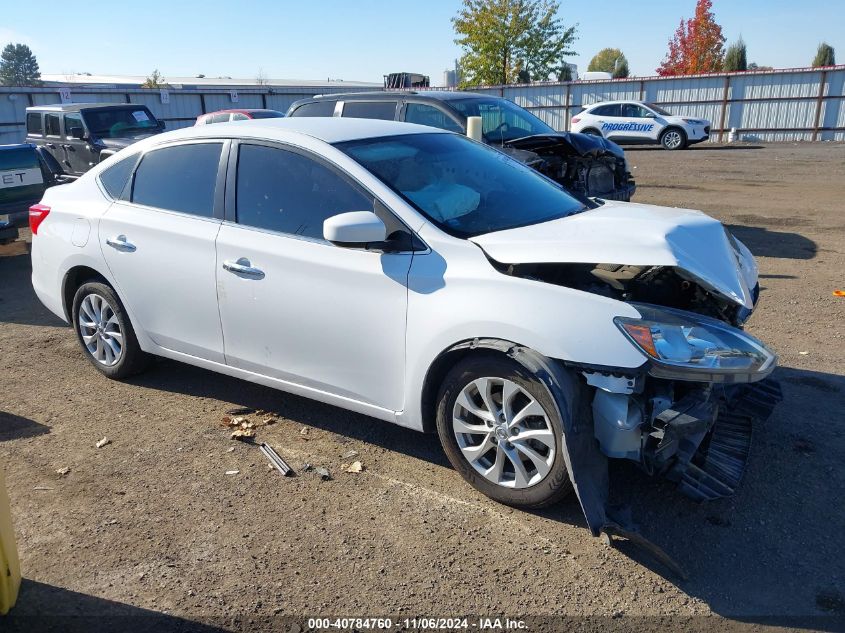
[452,377,556,489]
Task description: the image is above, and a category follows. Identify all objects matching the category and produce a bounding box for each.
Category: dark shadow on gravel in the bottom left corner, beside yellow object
[5,579,233,633]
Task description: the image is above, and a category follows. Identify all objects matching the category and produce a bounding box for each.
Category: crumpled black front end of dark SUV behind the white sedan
[503,132,636,202]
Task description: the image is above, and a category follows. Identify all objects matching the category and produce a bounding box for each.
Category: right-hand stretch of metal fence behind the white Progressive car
[462,66,845,141]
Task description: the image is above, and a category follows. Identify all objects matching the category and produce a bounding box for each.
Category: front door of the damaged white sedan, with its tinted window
[217,141,412,411]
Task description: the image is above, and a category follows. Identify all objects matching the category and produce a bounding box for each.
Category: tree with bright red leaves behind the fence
[657,0,725,77]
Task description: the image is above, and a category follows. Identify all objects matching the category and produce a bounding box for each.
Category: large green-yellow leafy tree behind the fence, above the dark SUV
[452,0,576,86]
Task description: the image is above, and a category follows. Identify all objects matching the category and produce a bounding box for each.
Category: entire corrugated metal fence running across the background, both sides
[0,66,845,143]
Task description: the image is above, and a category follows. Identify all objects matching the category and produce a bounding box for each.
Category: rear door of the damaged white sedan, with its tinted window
[99,140,228,363]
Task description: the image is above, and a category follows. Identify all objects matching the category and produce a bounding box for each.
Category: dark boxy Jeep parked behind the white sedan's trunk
[26,103,164,176]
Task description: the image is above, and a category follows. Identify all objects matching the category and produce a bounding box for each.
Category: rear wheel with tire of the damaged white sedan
[72,281,152,380]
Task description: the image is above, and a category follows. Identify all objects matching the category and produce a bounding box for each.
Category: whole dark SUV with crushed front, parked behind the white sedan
[287,91,636,202]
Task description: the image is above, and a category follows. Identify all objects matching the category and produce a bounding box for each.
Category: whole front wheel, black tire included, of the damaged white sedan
[437,354,572,509]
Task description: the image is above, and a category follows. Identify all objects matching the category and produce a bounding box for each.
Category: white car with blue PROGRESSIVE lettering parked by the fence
[571,101,710,150]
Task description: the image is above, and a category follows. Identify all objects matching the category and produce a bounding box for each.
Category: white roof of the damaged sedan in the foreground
[158,117,449,143]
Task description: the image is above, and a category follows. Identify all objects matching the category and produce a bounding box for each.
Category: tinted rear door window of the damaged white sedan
[132,143,223,218]
